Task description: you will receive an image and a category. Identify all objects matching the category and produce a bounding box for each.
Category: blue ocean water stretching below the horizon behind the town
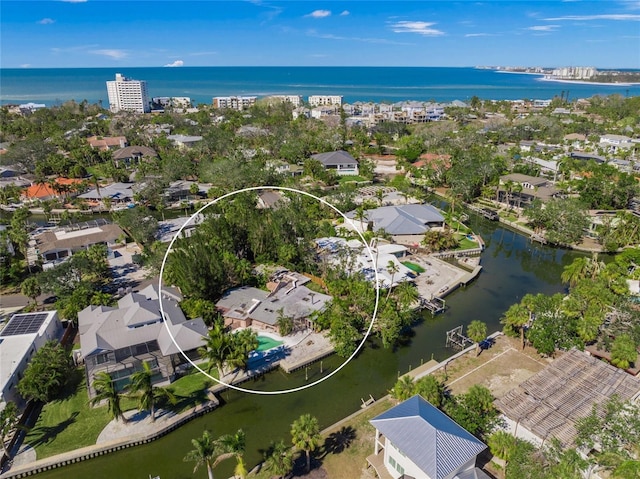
[0,67,640,106]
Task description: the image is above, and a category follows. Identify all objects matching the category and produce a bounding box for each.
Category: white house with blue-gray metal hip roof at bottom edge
[367,395,489,479]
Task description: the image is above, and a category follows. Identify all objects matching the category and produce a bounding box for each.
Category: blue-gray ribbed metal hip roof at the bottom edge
[370,395,487,479]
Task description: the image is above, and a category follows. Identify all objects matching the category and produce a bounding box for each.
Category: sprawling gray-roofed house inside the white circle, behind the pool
[216,270,333,331]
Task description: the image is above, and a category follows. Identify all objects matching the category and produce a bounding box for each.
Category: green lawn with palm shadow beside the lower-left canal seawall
[25,368,110,459]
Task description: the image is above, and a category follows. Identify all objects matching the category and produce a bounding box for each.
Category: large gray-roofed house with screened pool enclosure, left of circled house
[78,285,207,397]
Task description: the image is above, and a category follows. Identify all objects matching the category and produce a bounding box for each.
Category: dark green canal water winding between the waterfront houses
[38,215,578,479]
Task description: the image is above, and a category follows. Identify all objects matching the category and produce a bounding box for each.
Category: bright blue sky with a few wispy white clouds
[0,0,640,68]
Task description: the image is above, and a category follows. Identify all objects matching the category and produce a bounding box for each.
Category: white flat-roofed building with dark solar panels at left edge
[0,311,63,409]
